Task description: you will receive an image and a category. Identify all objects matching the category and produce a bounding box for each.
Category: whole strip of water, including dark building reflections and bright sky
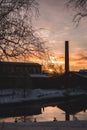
[0,92,87,122]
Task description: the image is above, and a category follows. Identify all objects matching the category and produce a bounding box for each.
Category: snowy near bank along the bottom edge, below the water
[0,121,87,130]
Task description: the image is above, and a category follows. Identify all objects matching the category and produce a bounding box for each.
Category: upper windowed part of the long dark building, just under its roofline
[0,62,41,75]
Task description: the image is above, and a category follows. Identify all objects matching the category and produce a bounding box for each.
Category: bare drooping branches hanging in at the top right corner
[67,0,87,25]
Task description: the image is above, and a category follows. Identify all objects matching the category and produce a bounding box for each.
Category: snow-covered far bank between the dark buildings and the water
[0,89,86,104]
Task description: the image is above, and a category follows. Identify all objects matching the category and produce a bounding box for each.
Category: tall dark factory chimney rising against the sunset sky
[65,41,69,73]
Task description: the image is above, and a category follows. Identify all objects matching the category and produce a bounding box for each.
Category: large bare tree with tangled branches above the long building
[0,0,44,60]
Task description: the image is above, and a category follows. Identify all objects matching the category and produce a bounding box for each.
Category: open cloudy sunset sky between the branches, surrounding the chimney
[33,0,87,70]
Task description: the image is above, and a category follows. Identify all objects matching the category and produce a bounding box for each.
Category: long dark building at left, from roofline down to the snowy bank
[0,62,41,89]
